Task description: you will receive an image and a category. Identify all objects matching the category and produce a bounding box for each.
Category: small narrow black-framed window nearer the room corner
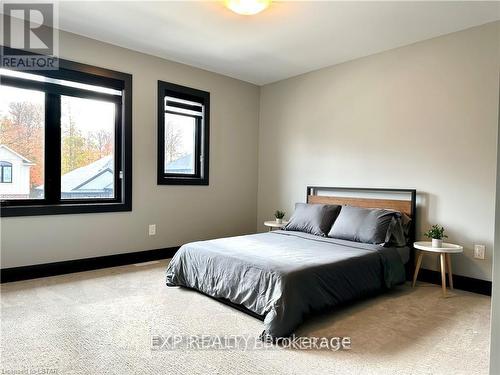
[158,81,210,185]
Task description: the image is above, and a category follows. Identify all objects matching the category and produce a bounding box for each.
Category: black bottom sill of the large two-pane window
[0,202,132,217]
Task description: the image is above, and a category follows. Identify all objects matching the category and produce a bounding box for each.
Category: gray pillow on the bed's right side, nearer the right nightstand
[328,206,401,245]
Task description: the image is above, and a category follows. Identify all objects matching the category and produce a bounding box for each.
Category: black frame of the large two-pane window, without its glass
[0,47,132,217]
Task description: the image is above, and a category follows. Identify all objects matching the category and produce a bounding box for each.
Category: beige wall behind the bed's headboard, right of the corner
[257,22,500,280]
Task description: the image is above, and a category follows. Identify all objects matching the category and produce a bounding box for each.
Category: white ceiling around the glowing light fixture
[54,1,500,85]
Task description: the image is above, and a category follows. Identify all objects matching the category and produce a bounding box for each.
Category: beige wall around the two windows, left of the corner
[1,33,259,268]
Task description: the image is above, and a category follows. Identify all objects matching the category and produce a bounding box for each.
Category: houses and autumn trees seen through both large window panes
[0,74,116,203]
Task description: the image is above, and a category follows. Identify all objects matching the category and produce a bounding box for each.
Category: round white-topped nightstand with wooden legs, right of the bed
[412,241,464,297]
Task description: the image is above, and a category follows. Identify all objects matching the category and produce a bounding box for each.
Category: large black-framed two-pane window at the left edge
[0,51,132,216]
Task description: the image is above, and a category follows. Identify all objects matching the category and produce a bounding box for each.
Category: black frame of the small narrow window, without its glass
[157,81,210,185]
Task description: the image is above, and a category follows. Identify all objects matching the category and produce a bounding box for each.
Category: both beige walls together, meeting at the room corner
[0,22,500,280]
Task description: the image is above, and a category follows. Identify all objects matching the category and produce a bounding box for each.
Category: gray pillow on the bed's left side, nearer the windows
[283,203,340,236]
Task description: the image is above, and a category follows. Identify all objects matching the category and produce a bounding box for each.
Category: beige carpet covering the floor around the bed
[0,261,490,375]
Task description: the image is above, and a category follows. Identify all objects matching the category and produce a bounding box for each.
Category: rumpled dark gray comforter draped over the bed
[167,231,409,337]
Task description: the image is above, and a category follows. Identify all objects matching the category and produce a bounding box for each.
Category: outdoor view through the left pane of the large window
[0,85,45,199]
